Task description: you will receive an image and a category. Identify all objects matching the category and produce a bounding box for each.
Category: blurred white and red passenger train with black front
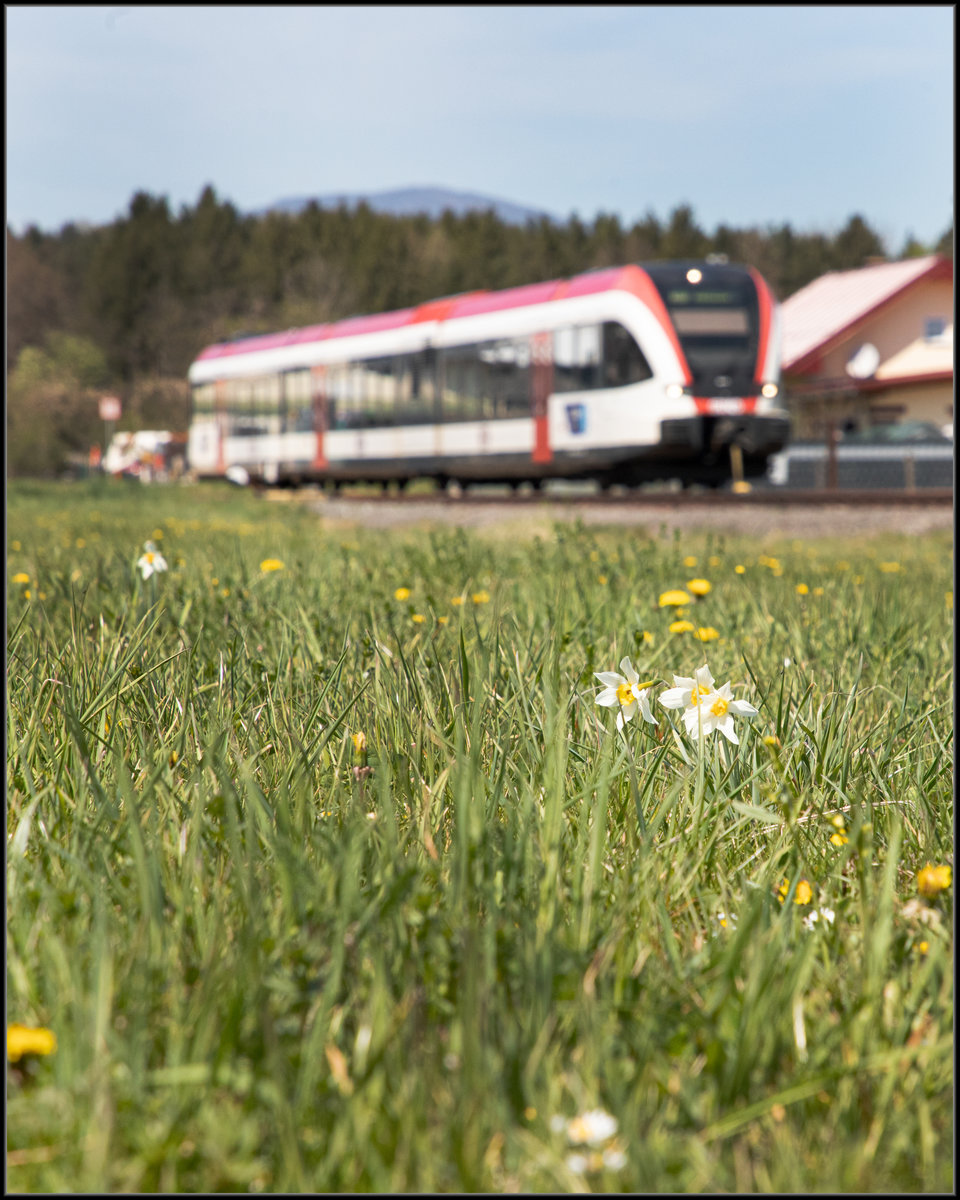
[187,260,790,490]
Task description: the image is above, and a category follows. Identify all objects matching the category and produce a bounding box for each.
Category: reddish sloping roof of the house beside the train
[780,254,953,373]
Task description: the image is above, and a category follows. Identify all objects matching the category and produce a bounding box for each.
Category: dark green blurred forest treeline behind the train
[7,187,953,474]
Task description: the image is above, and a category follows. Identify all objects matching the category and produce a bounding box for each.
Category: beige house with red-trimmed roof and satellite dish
[780,254,953,438]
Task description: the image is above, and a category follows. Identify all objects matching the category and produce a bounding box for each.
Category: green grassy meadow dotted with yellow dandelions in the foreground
[6,480,953,1193]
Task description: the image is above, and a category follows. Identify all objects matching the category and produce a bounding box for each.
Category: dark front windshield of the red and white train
[646,264,760,396]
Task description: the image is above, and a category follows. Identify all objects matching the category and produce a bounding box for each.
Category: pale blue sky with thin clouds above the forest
[5,5,954,254]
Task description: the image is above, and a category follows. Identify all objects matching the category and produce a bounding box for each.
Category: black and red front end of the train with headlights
[643,263,790,482]
